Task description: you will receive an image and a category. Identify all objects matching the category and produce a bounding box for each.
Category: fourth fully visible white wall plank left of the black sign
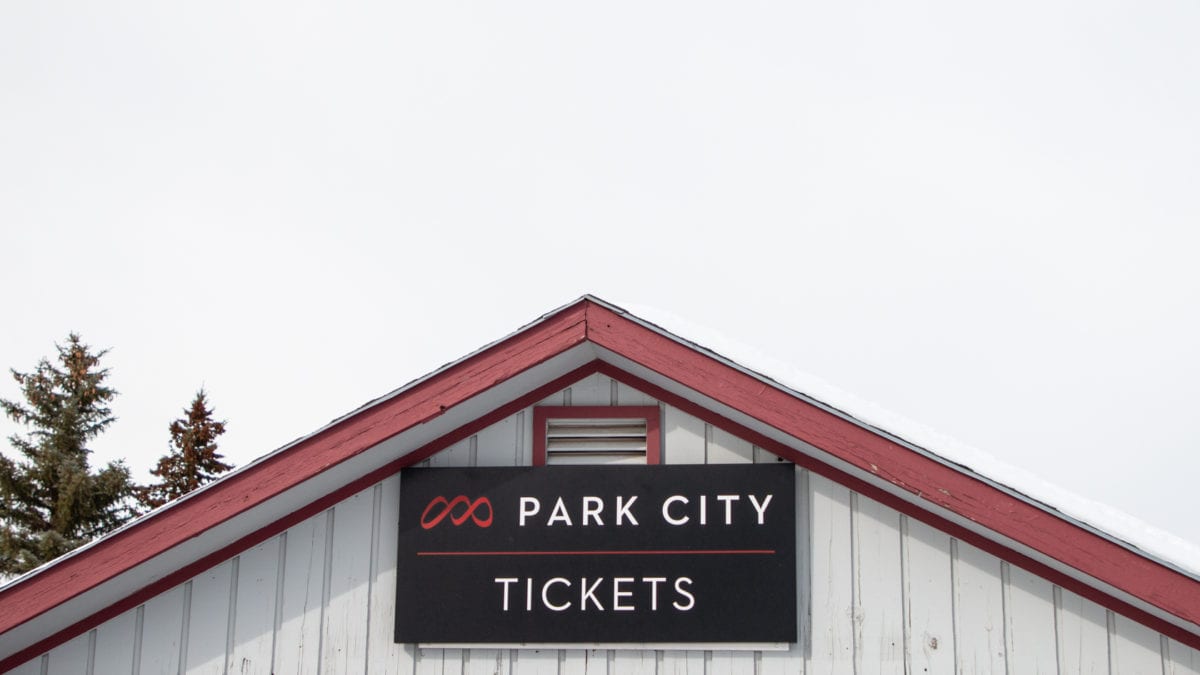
[187,558,236,675]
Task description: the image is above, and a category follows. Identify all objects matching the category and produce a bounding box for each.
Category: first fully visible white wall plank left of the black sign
[320,488,374,674]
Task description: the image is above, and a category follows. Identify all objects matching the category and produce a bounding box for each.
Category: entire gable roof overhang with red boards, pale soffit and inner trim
[0,297,1200,670]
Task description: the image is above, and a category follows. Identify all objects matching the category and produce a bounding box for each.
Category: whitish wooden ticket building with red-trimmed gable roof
[0,297,1200,675]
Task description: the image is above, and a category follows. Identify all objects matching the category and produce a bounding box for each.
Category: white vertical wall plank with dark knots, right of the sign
[902,518,954,673]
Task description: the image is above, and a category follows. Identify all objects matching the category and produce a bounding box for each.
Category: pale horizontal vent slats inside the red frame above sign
[546,418,646,464]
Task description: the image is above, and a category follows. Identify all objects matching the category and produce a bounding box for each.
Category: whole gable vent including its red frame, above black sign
[534,406,659,466]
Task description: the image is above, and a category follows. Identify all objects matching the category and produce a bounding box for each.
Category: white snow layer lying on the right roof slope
[617,299,1200,577]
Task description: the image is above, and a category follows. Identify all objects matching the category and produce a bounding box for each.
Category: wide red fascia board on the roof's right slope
[587,304,1200,638]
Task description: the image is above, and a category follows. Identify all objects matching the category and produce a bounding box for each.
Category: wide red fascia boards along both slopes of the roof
[0,294,1200,647]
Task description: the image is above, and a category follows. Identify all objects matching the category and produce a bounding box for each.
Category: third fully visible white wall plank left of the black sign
[226,537,281,675]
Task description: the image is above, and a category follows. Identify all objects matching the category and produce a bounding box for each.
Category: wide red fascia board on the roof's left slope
[0,298,587,634]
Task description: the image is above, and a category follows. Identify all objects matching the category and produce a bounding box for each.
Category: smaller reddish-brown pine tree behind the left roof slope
[137,389,233,509]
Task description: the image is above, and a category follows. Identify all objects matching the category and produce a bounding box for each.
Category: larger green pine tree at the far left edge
[0,333,133,574]
